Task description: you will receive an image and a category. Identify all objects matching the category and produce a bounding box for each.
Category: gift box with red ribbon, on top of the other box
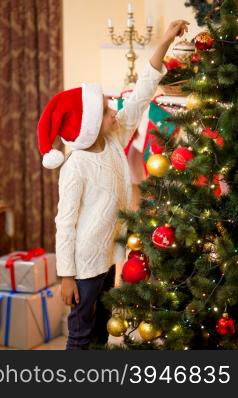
[0,249,57,293]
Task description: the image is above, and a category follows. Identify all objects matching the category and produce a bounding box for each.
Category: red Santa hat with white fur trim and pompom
[37,83,103,169]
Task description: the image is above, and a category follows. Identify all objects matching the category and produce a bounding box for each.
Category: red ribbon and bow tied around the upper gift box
[5,247,48,291]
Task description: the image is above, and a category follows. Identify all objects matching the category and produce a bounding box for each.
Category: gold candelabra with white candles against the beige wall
[108,4,153,86]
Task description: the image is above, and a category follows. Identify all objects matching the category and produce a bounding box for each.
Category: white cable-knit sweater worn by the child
[55,62,166,279]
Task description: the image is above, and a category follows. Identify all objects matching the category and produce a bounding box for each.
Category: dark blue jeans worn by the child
[66,265,115,350]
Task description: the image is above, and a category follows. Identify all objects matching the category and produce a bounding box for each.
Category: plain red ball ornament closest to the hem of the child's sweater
[122,257,150,284]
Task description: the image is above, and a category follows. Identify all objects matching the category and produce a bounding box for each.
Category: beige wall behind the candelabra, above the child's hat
[63,0,200,94]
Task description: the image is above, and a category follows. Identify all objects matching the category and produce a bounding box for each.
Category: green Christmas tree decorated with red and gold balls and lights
[103,0,238,350]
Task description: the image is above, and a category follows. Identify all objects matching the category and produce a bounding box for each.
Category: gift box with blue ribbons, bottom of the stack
[0,285,64,350]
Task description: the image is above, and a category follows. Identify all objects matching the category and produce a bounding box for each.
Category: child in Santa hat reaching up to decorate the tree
[37,20,188,350]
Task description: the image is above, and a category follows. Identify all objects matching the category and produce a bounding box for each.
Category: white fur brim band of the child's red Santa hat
[61,83,103,150]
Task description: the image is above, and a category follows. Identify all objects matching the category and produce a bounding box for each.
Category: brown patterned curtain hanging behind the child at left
[0,0,63,251]
